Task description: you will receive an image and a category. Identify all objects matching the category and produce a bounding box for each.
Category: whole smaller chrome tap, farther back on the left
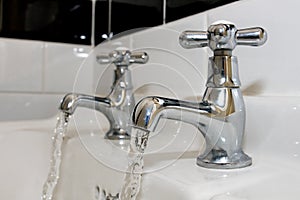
[59,50,148,140]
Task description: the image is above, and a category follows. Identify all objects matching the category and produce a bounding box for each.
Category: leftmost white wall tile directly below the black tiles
[0,38,44,92]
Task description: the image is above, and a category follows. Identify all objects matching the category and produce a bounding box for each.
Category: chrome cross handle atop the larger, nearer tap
[179,22,267,51]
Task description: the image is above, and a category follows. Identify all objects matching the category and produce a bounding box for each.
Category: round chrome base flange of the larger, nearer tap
[197,149,252,169]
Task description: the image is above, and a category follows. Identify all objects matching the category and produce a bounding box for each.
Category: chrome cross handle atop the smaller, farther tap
[96,50,149,67]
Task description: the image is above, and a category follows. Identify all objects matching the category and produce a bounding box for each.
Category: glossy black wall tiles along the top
[0,0,236,45]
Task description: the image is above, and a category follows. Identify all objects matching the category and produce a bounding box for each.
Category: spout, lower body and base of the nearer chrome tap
[132,88,252,169]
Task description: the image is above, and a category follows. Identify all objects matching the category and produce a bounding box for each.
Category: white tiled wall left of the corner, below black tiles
[0,38,94,121]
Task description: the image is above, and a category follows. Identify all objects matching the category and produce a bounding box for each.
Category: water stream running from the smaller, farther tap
[42,112,69,200]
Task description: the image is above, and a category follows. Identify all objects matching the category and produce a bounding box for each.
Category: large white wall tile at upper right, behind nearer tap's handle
[208,0,300,96]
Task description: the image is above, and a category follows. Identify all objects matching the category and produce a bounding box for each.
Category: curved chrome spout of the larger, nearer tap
[132,96,215,132]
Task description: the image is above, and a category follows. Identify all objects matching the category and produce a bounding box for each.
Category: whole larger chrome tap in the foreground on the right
[132,23,267,169]
